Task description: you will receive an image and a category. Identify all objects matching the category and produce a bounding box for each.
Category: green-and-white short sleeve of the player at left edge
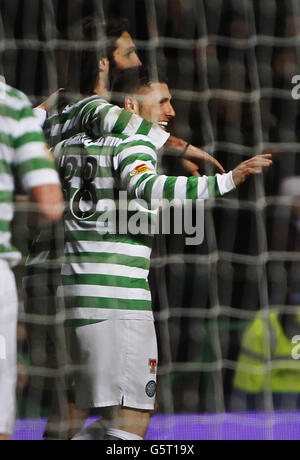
[14,95,60,191]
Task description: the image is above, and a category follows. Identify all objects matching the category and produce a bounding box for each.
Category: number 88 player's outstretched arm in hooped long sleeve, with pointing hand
[114,141,272,203]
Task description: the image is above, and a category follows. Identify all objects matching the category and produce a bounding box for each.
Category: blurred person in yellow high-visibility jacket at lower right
[231,307,300,411]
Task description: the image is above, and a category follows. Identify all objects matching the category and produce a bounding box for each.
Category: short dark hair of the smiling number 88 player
[112,66,168,105]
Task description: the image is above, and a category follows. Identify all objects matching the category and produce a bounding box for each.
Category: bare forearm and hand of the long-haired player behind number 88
[166,136,225,176]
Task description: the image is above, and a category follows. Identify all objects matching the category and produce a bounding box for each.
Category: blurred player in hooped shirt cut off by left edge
[0,77,62,440]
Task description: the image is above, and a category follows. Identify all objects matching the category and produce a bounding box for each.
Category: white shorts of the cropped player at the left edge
[0,259,18,434]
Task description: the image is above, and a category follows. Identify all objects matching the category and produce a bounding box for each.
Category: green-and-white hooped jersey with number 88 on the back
[54,129,234,325]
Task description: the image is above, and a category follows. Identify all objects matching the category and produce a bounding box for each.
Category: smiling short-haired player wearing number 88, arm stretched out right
[54,67,272,440]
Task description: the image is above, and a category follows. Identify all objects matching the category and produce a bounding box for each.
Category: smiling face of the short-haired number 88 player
[138,83,175,131]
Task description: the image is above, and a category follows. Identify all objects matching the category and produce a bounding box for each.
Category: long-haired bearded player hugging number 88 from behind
[27,19,224,439]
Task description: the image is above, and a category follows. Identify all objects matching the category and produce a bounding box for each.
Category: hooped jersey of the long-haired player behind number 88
[26,95,169,288]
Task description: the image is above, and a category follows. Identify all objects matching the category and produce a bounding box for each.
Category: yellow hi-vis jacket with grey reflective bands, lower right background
[234,311,300,394]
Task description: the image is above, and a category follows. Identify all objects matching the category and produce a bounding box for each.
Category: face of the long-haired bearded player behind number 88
[113,32,142,70]
